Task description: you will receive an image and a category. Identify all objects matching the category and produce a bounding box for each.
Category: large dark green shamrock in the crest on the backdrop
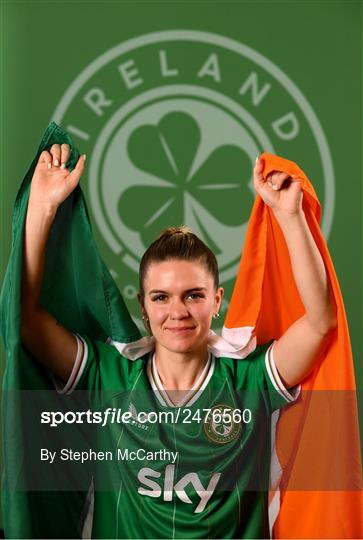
[118,111,253,255]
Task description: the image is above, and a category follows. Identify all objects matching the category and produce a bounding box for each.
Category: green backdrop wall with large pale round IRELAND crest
[0,0,363,532]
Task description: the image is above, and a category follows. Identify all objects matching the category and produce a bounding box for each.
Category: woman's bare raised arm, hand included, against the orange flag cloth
[253,159,337,388]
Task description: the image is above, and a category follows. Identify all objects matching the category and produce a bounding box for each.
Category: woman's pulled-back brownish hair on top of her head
[139,225,219,298]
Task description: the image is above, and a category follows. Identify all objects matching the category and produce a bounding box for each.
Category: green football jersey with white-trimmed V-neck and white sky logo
[64,336,300,538]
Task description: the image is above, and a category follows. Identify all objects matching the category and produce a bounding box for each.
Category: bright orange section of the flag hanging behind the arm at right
[224,153,363,538]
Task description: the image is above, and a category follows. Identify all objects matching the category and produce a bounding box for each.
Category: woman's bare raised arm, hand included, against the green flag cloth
[21,144,85,381]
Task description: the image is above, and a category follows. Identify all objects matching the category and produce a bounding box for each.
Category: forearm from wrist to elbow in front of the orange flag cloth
[274,210,335,333]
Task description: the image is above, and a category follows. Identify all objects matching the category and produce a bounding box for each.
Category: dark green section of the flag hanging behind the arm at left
[0,122,141,538]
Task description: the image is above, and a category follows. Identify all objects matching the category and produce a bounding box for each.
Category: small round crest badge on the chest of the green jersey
[204,404,241,444]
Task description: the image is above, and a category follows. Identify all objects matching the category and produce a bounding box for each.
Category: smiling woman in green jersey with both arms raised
[22,141,335,538]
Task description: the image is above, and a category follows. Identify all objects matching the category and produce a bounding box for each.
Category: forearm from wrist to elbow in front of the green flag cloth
[21,204,55,315]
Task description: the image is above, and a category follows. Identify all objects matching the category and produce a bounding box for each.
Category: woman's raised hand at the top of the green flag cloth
[29,144,86,212]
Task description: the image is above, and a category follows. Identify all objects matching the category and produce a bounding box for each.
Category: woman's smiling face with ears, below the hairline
[139,259,224,352]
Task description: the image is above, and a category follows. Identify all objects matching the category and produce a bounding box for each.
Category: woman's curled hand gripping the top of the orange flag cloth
[253,158,303,214]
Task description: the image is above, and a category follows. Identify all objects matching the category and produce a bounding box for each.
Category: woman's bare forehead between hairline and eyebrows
[144,259,213,291]
